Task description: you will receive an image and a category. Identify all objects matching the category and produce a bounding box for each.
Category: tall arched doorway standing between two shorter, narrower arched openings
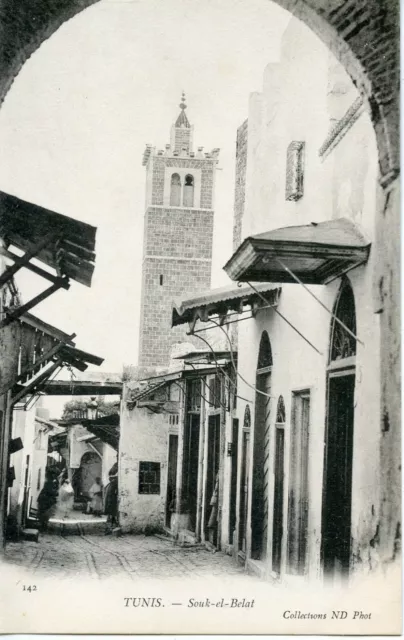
[251,331,272,560]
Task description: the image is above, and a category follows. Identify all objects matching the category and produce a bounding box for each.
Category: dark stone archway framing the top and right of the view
[0,0,401,560]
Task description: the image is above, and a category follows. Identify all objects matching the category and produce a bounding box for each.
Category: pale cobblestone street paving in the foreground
[5,531,256,581]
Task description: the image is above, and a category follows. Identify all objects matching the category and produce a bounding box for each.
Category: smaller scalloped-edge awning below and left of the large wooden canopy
[172,283,280,327]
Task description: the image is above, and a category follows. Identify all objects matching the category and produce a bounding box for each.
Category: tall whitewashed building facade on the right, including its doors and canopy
[170,20,385,586]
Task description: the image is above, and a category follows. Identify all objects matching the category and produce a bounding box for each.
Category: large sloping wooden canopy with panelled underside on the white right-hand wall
[224,218,370,284]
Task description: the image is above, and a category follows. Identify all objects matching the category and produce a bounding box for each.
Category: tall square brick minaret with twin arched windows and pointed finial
[139,93,219,366]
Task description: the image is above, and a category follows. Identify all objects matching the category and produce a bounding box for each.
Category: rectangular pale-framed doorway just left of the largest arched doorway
[287,391,310,575]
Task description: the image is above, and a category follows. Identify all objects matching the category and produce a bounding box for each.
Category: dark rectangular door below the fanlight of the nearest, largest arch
[322,373,355,575]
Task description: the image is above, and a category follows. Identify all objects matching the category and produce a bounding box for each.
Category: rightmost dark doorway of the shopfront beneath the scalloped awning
[205,415,220,547]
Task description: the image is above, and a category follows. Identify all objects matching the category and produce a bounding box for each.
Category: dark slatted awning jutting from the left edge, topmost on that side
[0,191,97,287]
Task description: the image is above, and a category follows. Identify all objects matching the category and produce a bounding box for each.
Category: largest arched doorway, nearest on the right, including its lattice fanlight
[322,279,356,576]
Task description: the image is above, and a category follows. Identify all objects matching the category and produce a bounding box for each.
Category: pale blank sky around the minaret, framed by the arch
[0,0,290,416]
